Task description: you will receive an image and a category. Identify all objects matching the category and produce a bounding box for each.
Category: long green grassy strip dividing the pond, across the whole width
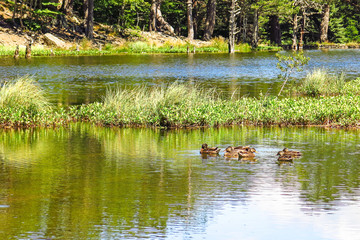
[0,75,360,127]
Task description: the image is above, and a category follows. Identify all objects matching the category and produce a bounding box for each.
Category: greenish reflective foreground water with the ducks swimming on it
[0,124,360,240]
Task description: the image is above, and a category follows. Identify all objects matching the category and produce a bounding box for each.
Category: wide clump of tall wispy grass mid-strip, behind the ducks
[95,83,220,126]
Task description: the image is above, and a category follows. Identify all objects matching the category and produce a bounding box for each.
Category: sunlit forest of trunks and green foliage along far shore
[6,0,360,49]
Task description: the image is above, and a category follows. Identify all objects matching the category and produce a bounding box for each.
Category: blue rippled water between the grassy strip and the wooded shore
[0,50,360,104]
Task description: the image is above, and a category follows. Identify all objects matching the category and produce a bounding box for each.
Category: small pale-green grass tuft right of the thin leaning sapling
[296,69,346,96]
